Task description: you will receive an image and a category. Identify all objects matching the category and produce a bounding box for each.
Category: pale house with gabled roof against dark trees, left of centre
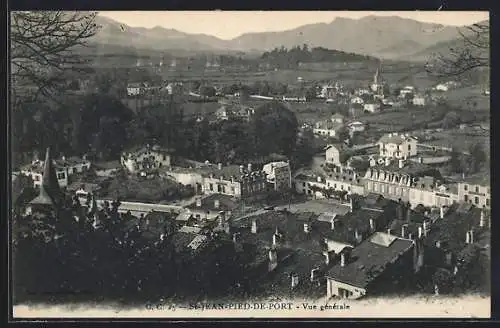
[120,145,171,173]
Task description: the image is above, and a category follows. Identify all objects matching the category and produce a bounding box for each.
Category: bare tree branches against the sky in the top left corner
[10,11,99,102]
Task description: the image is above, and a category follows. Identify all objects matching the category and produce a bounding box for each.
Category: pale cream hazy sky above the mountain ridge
[100,10,489,39]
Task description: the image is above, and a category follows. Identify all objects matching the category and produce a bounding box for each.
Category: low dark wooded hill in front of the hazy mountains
[260,44,374,69]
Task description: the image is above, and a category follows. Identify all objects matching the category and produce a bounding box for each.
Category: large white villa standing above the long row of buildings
[378,133,417,159]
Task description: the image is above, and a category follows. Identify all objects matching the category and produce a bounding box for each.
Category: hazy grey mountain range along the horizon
[92,16,488,60]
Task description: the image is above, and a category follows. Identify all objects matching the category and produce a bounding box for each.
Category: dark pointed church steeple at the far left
[30,147,63,207]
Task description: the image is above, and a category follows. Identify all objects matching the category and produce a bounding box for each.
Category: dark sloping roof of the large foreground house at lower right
[327,232,414,288]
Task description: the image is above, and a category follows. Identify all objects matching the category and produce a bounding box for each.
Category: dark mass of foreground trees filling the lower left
[13,202,250,303]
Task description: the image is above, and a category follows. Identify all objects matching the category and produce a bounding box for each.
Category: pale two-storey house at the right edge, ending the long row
[458,175,491,209]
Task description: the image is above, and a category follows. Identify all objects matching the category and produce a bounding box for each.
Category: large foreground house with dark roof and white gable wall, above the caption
[327,232,415,299]
